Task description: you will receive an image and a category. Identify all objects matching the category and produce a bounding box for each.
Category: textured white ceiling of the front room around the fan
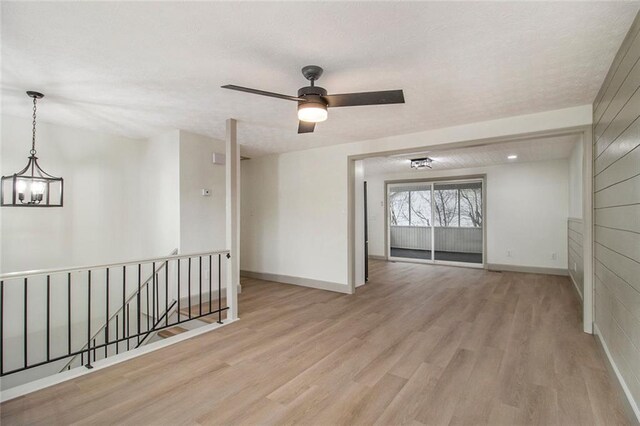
[1,1,639,156]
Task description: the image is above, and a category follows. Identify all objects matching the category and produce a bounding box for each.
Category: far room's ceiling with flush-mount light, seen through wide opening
[363,135,580,176]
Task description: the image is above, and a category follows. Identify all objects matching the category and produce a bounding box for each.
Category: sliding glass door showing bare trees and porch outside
[387,180,484,266]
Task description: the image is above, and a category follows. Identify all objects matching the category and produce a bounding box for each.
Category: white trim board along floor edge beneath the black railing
[0,319,238,402]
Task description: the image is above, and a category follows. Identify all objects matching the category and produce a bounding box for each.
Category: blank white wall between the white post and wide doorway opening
[240,147,347,283]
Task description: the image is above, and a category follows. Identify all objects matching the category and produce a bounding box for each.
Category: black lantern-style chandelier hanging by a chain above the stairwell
[0,91,64,207]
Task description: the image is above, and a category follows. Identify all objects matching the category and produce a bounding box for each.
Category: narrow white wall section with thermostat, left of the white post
[180,130,226,253]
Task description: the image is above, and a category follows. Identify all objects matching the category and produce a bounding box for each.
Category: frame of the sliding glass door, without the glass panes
[384,174,487,269]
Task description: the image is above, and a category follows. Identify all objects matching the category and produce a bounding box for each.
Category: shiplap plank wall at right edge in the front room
[593,10,640,415]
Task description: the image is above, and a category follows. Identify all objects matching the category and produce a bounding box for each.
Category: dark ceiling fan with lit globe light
[222,65,404,133]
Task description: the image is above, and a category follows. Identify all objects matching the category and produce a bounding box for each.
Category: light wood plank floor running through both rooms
[0,261,626,425]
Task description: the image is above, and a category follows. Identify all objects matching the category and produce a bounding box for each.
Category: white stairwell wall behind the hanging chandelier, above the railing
[0,117,178,272]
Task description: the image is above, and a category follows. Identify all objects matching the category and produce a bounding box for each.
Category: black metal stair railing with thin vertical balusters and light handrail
[0,250,229,386]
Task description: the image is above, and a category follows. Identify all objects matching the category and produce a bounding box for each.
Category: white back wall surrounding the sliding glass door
[365,160,569,268]
